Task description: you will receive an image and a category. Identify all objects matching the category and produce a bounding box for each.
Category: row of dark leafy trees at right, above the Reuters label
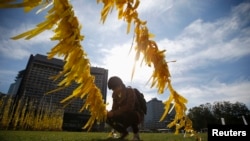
[188,101,250,130]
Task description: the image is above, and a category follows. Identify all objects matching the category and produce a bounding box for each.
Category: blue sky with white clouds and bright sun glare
[0,0,250,108]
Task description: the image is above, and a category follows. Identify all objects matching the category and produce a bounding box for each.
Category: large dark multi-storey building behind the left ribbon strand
[15,54,108,130]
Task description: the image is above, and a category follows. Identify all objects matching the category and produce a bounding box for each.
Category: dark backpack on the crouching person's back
[130,87,147,115]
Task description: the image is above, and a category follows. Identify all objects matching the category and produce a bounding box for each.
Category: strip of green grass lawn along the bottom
[0,130,207,141]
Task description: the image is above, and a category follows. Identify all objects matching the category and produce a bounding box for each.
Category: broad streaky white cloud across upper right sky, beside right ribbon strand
[158,1,250,73]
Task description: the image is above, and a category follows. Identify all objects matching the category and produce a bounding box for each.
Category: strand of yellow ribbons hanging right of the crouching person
[97,0,187,133]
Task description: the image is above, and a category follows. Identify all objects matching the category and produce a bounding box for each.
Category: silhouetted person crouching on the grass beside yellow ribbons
[106,76,144,140]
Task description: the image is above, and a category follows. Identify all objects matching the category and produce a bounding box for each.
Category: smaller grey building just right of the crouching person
[144,98,175,131]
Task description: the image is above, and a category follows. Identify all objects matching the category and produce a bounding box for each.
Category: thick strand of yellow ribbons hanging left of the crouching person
[0,0,107,129]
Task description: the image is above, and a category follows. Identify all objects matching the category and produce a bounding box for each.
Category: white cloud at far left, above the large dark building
[0,19,54,60]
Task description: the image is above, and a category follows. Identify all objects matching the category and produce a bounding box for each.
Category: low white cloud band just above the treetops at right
[179,81,250,108]
